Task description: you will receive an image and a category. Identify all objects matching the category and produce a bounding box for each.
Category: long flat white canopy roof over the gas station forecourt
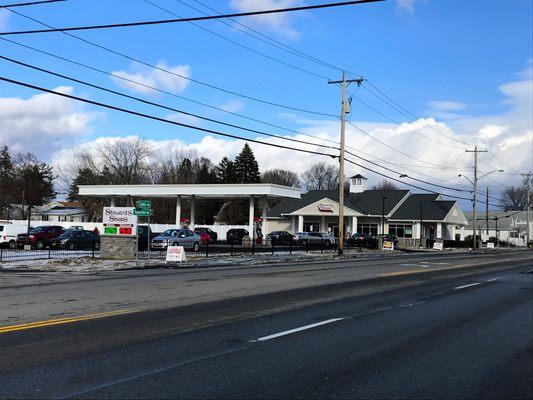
[78,183,301,199]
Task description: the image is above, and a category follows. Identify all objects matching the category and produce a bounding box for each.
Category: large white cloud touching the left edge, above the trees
[0,87,97,158]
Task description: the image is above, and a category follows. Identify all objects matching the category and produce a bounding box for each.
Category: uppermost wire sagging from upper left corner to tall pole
[0,6,336,118]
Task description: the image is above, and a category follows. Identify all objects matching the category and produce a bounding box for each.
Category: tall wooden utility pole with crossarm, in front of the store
[328,71,364,256]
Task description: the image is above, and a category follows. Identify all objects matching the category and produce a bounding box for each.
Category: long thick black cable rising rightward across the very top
[0,0,385,36]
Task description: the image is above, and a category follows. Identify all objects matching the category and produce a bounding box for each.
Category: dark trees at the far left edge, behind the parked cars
[0,146,56,219]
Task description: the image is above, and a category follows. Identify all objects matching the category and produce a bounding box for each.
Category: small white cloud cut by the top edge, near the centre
[230,0,304,39]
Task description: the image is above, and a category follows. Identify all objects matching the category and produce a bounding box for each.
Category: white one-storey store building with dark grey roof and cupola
[268,175,468,246]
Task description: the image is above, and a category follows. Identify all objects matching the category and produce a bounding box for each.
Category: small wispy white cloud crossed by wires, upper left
[112,61,192,95]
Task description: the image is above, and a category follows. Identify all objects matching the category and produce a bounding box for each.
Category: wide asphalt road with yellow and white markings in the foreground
[0,252,533,398]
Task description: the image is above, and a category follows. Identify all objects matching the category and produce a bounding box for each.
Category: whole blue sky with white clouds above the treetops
[0,0,533,208]
